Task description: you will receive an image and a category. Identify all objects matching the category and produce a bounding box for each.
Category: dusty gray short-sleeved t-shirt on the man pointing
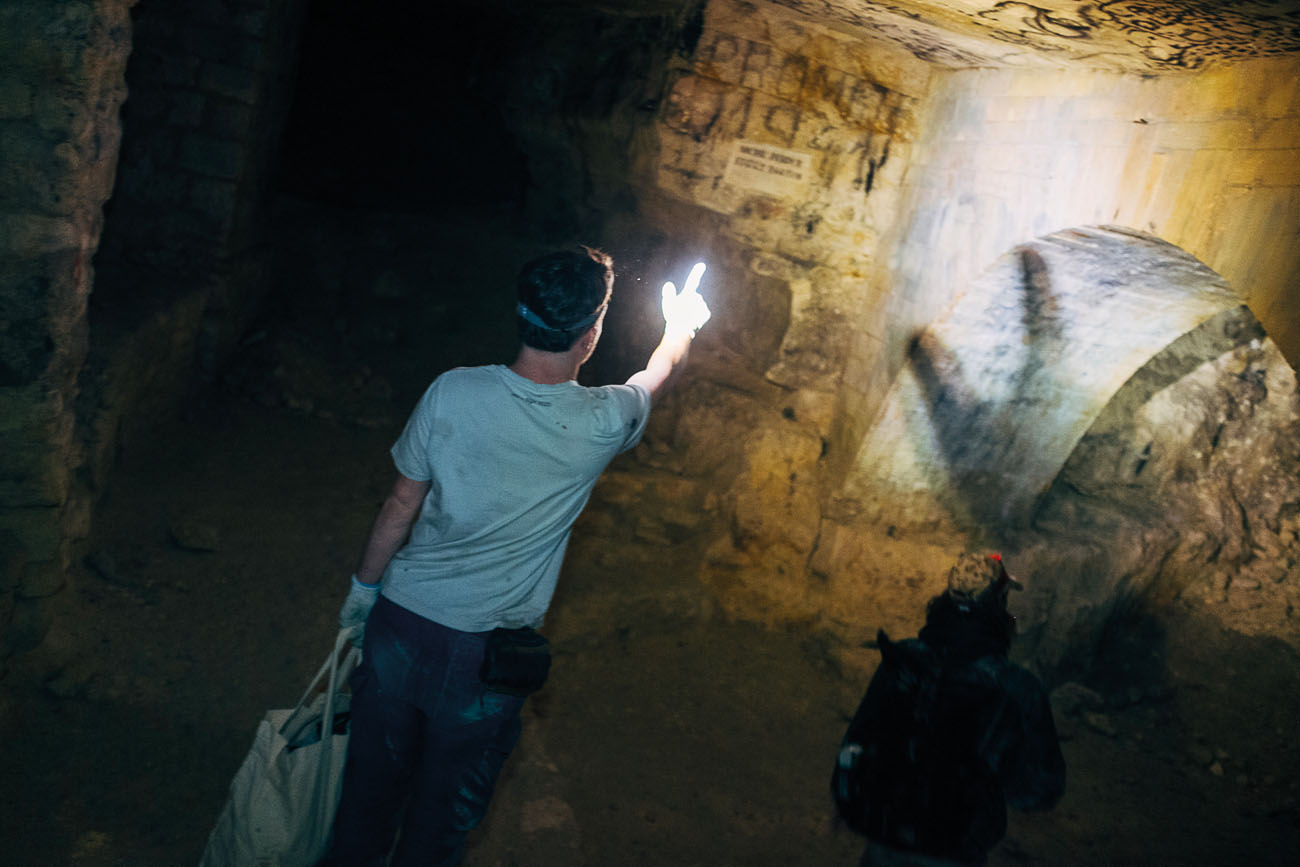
[384,364,650,632]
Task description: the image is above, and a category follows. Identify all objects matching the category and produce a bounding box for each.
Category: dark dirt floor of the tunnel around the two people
[0,206,1300,867]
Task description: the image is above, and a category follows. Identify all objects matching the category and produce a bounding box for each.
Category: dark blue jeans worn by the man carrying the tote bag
[322,597,524,867]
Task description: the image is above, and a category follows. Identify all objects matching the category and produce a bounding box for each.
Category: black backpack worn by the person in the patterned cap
[832,632,1006,861]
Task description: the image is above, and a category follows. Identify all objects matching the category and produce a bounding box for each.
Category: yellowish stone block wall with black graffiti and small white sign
[598,0,933,621]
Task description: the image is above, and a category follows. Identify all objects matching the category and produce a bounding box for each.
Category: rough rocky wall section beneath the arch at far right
[1010,307,1300,677]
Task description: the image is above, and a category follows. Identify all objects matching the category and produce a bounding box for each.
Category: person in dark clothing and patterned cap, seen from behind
[831,554,1065,867]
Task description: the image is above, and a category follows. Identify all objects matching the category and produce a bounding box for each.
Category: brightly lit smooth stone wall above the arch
[844,57,1300,467]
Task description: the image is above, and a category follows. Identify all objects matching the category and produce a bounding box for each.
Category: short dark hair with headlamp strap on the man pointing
[515,247,614,352]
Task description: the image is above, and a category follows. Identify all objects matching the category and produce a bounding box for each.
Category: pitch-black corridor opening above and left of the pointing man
[277,0,527,213]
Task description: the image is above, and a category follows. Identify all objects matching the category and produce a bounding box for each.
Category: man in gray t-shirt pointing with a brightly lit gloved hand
[325,248,709,867]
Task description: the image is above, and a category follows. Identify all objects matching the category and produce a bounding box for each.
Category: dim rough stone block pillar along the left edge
[0,0,131,664]
